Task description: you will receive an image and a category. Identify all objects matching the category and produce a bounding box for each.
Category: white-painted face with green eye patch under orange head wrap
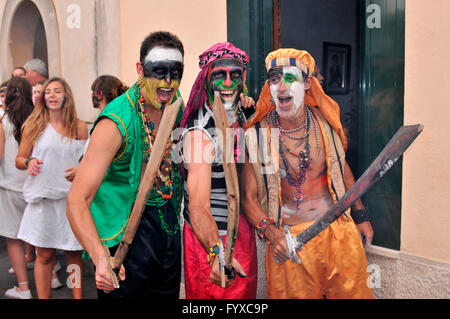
[269,66,306,118]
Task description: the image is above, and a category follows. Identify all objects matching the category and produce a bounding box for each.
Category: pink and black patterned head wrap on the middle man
[180,42,248,127]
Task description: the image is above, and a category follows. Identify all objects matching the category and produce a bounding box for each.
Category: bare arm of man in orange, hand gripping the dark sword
[239,158,290,261]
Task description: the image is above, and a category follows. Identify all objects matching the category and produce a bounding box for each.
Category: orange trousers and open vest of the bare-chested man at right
[249,108,373,299]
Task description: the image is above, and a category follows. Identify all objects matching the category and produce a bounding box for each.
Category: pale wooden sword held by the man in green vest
[103,98,182,288]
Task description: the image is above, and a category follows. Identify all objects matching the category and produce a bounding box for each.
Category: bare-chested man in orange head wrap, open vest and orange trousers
[240,49,373,298]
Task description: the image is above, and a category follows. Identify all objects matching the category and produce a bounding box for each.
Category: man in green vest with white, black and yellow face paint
[67,32,184,299]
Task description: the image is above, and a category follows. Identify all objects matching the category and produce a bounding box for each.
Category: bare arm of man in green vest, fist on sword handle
[67,119,122,290]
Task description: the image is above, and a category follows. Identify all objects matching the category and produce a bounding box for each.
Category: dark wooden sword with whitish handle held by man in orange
[284,124,423,263]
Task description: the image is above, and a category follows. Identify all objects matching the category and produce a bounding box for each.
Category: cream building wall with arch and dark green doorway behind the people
[0,0,450,298]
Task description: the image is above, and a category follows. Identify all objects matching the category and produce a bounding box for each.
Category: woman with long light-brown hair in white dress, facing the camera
[16,78,89,299]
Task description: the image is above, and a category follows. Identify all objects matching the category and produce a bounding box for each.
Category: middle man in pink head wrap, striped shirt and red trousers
[180,42,257,299]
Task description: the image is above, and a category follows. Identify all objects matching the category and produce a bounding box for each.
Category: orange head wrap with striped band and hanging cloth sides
[245,49,348,150]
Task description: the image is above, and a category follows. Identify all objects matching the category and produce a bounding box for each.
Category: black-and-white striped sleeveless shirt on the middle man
[180,106,228,236]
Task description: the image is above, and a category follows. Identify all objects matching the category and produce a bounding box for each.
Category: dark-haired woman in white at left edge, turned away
[0,78,34,299]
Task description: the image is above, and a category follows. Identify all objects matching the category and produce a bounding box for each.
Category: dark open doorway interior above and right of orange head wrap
[274,0,360,172]
